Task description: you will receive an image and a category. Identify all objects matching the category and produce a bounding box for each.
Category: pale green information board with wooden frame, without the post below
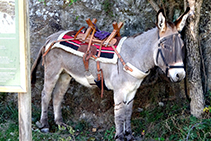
[0,0,28,92]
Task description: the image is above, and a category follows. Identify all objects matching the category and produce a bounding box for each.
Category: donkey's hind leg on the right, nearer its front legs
[53,72,72,125]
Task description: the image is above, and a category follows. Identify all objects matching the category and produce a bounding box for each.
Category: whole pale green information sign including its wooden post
[0,0,32,141]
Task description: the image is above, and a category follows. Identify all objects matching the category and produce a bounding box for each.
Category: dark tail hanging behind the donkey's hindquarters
[31,45,45,87]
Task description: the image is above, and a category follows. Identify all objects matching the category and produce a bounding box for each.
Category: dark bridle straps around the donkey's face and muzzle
[156,33,184,76]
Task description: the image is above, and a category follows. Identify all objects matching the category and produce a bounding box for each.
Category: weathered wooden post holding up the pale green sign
[18,0,32,141]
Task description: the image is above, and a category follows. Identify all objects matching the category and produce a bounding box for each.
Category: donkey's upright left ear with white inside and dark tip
[156,9,167,32]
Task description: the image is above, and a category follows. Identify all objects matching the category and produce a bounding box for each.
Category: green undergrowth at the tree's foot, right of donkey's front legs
[132,103,211,141]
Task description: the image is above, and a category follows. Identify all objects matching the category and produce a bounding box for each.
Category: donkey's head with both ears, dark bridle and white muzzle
[156,7,190,82]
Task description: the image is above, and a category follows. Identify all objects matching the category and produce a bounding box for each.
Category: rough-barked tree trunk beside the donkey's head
[185,0,204,117]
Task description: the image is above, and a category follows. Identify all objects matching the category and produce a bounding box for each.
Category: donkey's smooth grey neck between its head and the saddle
[121,28,158,72]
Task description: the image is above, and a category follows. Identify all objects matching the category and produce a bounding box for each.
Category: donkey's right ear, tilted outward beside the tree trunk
[174,7,190,32]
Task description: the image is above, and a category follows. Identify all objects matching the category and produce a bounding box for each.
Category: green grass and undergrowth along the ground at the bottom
[0,95,211,141]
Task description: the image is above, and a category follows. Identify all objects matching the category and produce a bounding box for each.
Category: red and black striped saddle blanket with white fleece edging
[45,31,126,64]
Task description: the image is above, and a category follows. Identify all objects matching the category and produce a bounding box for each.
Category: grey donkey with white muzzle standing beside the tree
[31,8,190,141]
